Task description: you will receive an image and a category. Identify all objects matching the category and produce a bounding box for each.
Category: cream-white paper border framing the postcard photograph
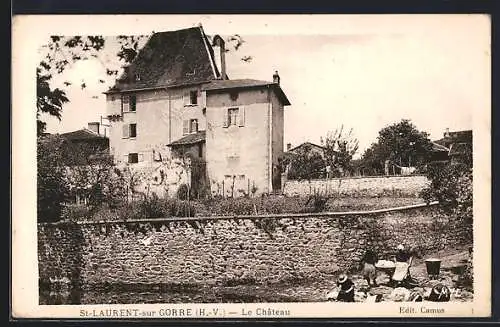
[11,15,492,319]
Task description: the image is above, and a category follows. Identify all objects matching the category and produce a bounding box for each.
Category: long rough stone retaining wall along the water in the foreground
[38,206,471,288]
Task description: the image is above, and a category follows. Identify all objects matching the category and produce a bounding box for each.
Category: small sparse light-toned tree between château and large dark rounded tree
[321,125,359,176]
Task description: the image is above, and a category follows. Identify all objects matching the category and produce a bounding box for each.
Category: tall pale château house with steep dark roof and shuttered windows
[106,26,290,196]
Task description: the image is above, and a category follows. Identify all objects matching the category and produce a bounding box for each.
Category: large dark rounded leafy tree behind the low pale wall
[362,119,432,171]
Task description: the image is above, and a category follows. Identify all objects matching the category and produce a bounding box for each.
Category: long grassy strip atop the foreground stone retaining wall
[61,196,424,221]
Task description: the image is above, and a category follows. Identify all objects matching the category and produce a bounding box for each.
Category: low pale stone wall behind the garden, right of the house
[283,175,429,196]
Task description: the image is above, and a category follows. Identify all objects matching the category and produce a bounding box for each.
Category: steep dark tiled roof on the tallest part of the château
[105,26,220,93]
